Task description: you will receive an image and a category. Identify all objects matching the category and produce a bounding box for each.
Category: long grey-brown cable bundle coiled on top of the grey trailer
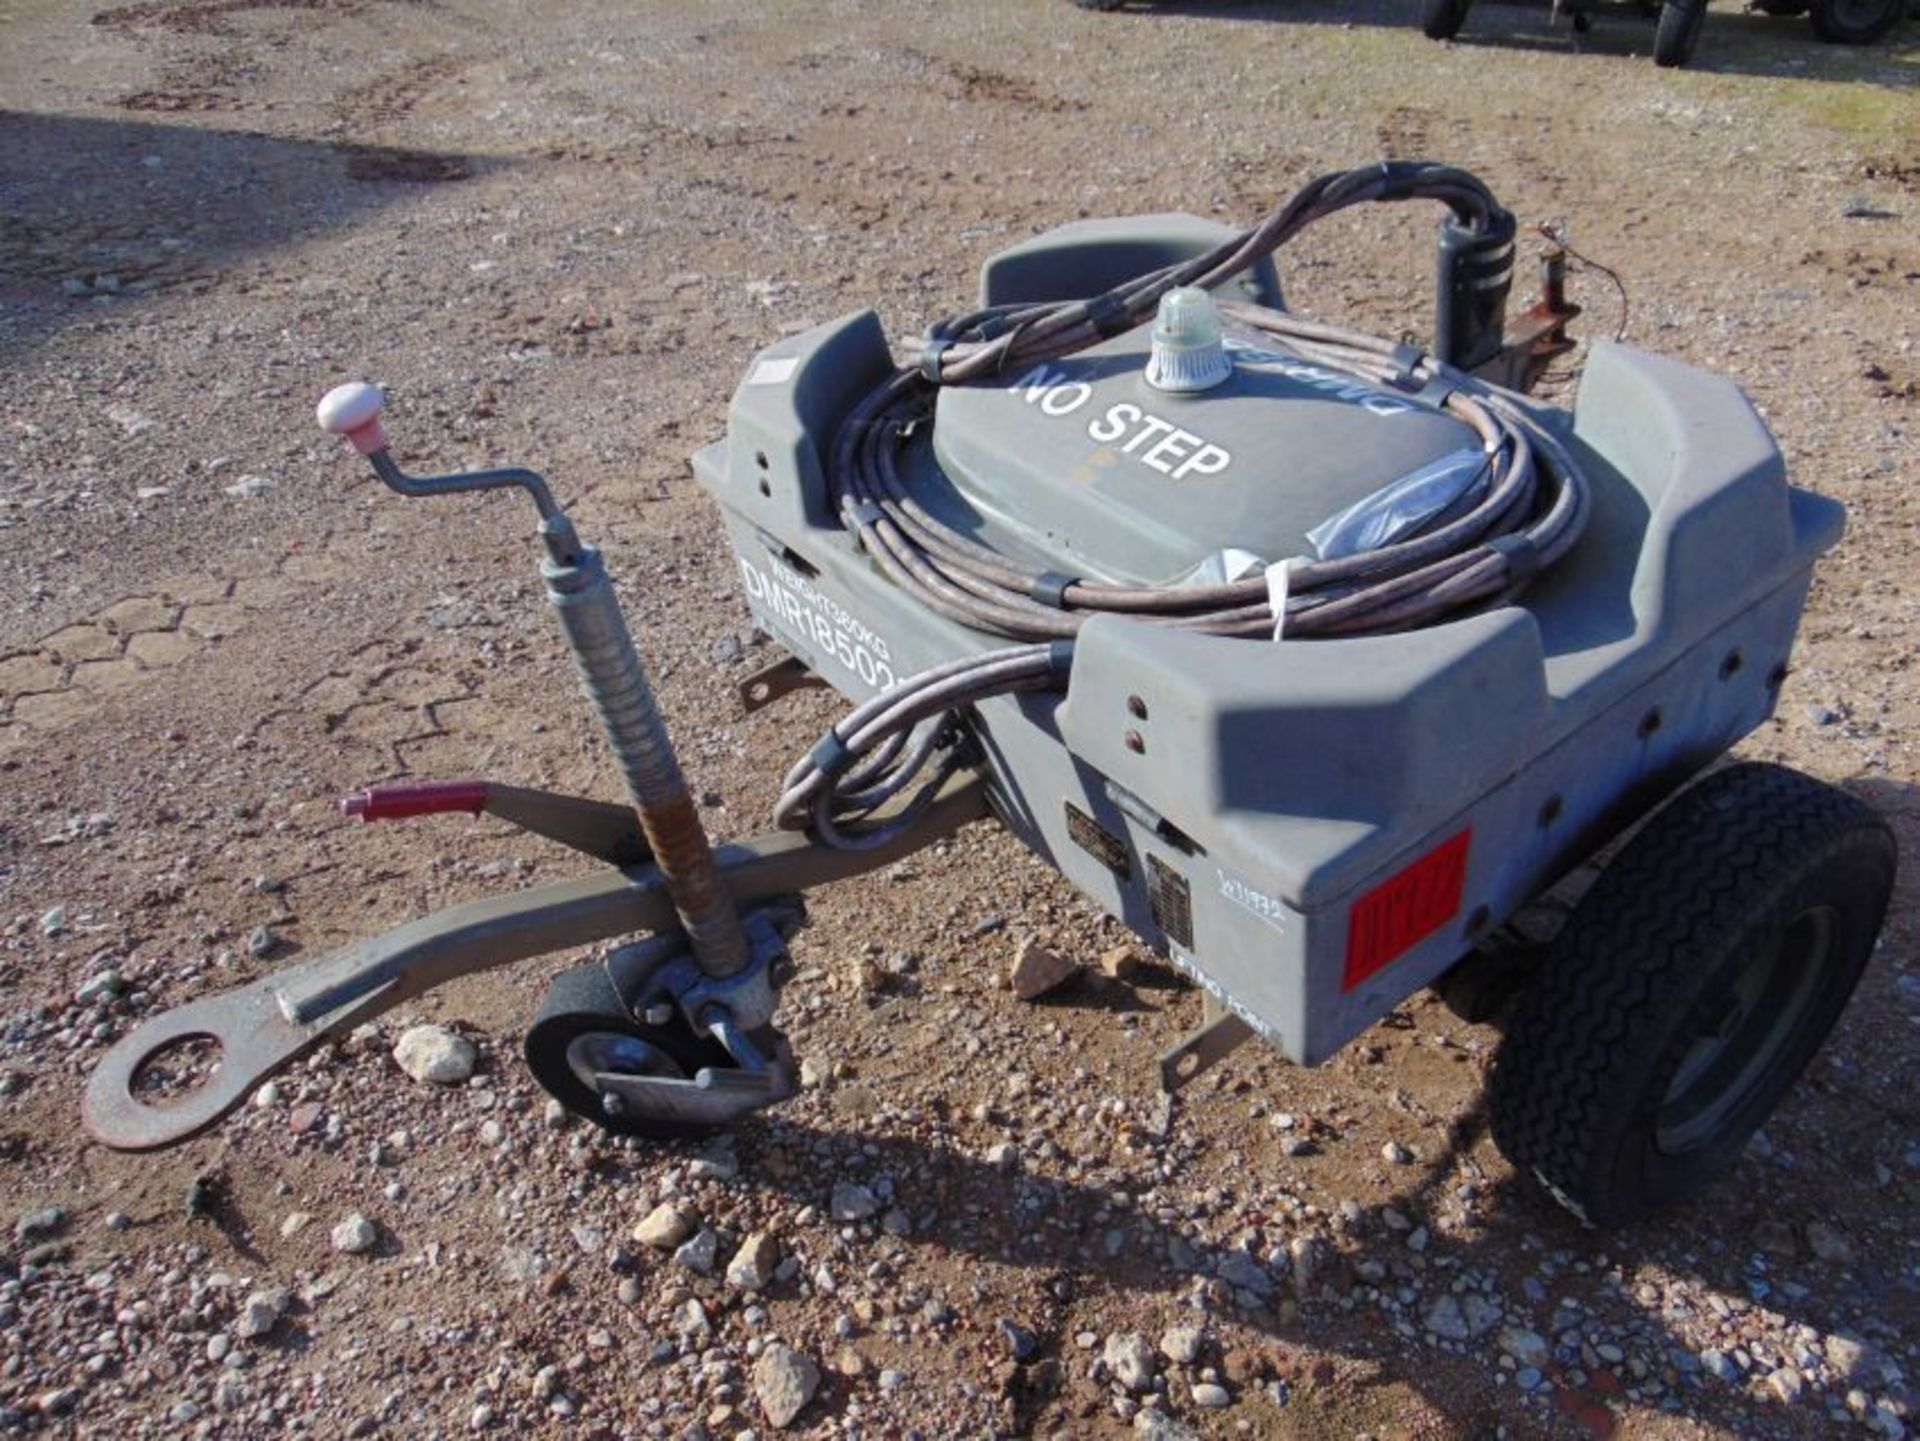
[776,161,1590,846]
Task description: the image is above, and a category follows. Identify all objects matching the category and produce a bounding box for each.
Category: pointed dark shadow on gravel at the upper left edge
[0,109,503,359]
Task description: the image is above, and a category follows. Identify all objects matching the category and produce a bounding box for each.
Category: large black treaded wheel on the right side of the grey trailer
[1490,764,1895,1226]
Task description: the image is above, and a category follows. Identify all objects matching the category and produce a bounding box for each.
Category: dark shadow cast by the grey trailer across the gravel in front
[755,840,1920,1437]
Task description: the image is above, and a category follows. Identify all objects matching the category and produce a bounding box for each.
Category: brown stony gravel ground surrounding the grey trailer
[0,0,1920,1439]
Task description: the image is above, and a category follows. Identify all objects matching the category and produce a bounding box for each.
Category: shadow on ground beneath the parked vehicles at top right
[1121,0,1920,90]
